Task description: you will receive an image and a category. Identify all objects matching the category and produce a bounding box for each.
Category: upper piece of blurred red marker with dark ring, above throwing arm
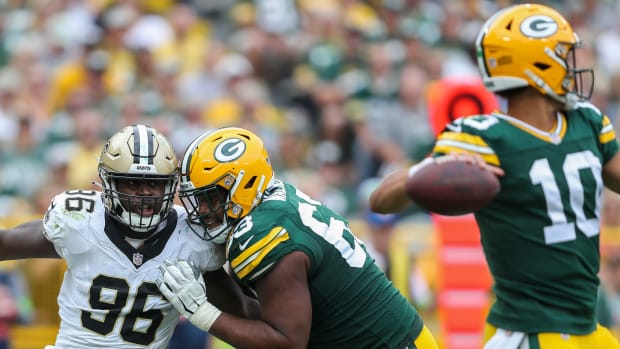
[428,76,499,136]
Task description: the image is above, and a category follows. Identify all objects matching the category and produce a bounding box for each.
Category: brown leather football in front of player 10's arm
[407,161,500,216]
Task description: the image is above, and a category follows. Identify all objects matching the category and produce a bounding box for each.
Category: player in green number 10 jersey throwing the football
[370,4,620,349]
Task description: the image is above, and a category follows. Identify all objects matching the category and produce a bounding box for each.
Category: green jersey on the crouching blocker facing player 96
[226,180,423,349]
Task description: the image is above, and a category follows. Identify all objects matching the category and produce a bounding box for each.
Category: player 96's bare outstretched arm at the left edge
[0,219,59,260]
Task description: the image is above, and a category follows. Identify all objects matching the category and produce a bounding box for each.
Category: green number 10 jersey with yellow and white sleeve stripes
[434,103,618,334]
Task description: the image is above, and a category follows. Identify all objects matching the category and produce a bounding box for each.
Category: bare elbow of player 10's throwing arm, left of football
[369,168,413,213]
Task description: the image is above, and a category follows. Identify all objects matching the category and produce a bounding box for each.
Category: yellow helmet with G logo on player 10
[476,4,594,109]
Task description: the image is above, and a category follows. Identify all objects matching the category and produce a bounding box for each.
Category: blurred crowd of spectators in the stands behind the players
[0,0,620,342]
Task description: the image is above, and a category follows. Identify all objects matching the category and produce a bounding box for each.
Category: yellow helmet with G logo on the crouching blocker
[179,127,274,244]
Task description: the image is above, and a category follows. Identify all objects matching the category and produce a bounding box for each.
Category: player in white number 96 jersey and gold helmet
[0,125,257,349]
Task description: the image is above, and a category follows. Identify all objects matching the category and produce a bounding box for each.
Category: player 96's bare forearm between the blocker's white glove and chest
[203,268,260,319]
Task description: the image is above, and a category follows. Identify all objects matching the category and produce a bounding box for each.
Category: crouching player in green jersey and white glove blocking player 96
[158,127,437,349]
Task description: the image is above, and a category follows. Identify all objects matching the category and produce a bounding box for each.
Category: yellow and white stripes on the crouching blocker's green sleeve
[230,227,289,279]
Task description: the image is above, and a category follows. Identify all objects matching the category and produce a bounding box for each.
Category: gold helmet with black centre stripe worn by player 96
[99,125,179,238]
